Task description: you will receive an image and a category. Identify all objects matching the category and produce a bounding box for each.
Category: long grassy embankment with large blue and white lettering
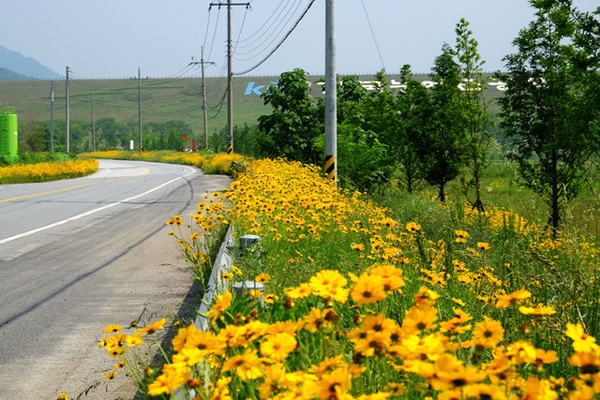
[0,75,501,135]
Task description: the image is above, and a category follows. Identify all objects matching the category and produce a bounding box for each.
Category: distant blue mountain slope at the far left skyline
[0,46,64,80]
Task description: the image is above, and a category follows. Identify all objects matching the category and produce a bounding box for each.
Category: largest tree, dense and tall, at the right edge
[499,0,600,235]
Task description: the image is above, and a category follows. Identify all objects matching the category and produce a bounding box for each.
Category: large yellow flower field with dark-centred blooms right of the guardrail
[89,159,600,399]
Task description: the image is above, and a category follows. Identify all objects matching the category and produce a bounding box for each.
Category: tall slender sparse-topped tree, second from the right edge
[454,18,492,212]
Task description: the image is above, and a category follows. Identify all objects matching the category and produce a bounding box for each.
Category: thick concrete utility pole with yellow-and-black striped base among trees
[325,0,337,181]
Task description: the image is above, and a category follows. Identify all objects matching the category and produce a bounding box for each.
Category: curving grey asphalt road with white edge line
[0,160,230,400]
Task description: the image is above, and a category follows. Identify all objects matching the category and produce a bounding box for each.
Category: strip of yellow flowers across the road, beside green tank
[0,159,98,184]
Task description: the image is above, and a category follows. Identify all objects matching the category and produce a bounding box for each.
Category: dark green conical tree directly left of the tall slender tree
[415,43,467,203]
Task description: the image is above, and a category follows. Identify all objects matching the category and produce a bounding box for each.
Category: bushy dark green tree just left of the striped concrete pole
[258,68,324,164]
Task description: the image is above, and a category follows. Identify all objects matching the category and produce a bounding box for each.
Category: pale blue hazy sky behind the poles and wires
[0,0,599,78]
